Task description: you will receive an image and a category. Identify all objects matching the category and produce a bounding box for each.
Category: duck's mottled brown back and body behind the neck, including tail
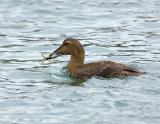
[73,61,141,77]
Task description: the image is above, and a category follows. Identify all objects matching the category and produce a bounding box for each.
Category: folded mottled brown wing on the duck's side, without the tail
[76,61,123,77]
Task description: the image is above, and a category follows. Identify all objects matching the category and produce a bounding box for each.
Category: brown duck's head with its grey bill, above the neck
[48,38,85,59]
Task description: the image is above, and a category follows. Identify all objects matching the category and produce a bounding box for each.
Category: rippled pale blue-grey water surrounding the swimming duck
[0,0,160,124]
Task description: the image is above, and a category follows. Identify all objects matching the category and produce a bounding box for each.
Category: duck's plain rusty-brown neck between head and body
[67,54,85,72]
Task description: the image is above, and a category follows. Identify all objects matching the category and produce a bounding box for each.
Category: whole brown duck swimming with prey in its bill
[45,38,143,78]
